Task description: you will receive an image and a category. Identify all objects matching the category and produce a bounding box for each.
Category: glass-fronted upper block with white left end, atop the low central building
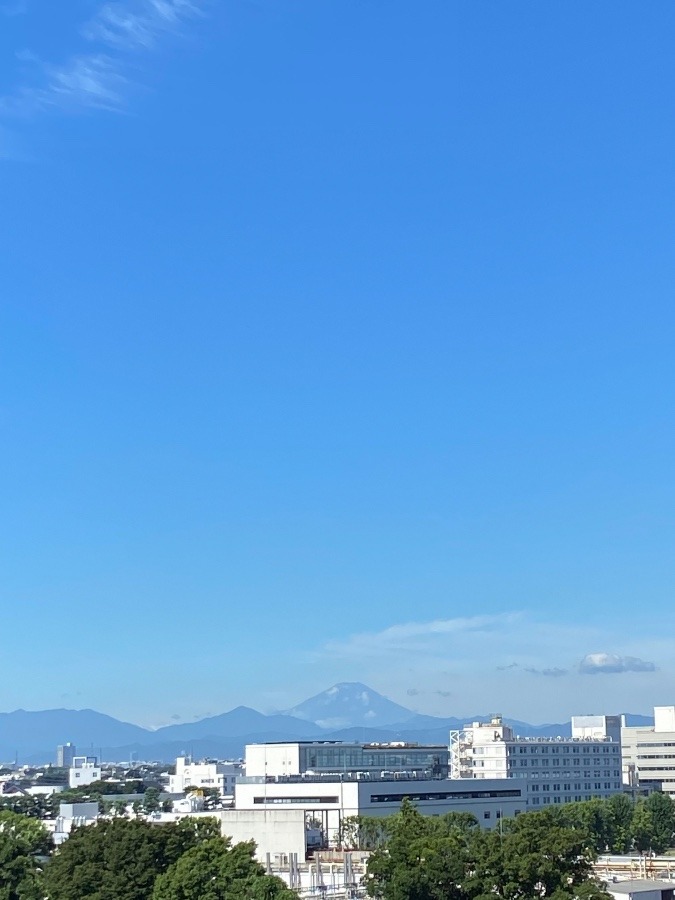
[246,741,449,779]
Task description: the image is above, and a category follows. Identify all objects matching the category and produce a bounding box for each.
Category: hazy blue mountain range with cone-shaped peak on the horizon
[0,683,653,764]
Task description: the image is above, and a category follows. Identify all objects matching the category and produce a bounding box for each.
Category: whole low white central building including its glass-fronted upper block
[235,741,526,849]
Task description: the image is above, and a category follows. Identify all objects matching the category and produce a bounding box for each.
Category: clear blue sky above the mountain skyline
[0,0,675,725]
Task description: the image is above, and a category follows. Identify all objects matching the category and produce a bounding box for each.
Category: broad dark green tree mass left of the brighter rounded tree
[45,818,220,900]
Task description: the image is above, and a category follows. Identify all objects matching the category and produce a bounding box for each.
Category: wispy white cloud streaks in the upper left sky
[0,0,207,116]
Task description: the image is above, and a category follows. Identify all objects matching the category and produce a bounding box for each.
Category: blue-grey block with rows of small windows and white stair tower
[450,716,622,808]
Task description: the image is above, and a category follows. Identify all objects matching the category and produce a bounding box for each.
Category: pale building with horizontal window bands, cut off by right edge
[621,706,675,799]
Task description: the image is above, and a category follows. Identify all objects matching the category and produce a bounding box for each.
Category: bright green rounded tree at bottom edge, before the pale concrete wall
[152,837,295,900]
